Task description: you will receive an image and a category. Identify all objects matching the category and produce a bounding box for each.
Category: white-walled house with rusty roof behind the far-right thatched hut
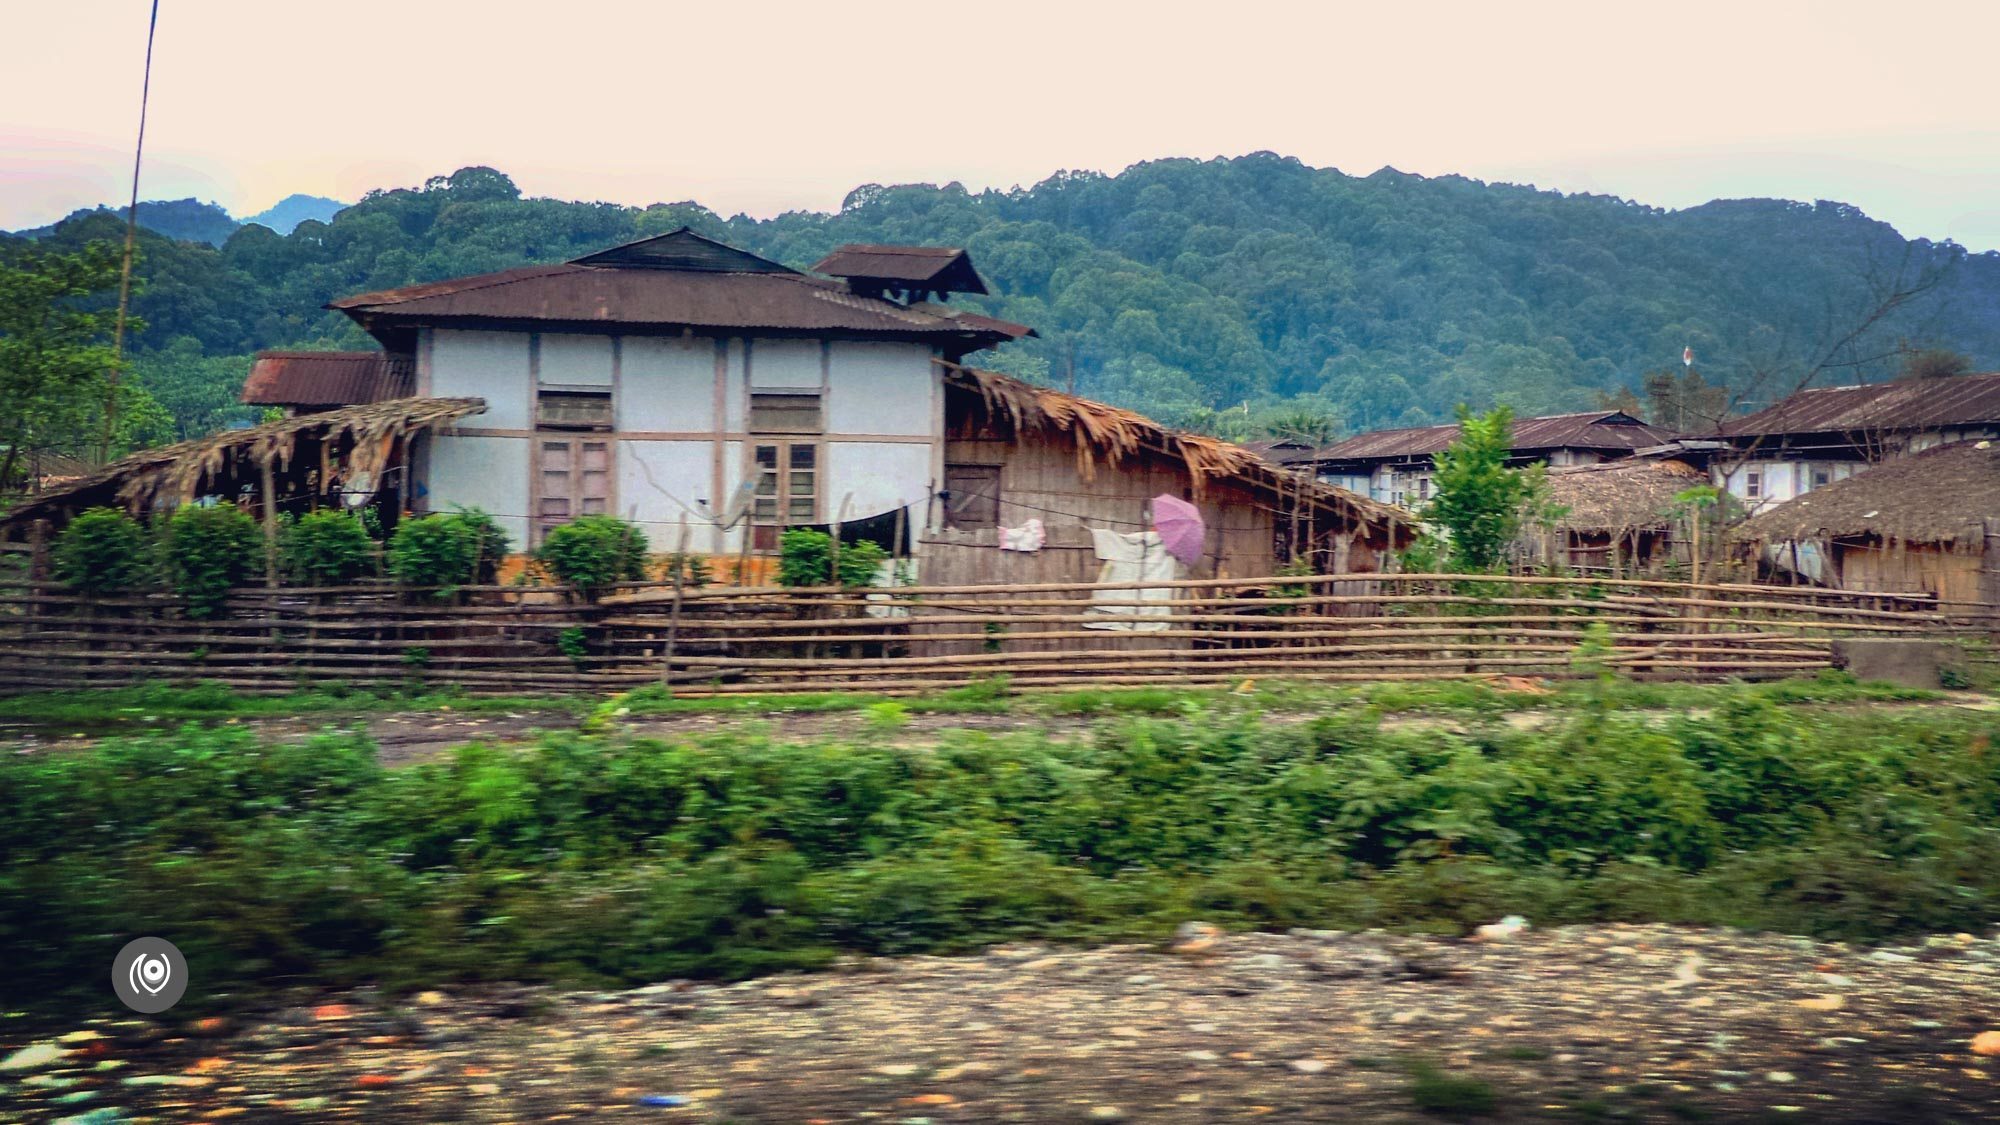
[1710,372,2000,510]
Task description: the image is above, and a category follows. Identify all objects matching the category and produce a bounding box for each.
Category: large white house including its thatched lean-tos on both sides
[10,230,1412,583]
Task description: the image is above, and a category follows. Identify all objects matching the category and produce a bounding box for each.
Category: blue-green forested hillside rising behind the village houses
[15,154,2000,430]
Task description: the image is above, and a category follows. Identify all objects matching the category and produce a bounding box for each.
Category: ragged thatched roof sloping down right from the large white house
[938,360,1416,540]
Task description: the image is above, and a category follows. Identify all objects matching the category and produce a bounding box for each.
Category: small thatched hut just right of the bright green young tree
[1530,458,1708,577]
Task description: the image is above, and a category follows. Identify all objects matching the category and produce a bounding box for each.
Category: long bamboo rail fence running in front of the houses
[0,575,1988,695]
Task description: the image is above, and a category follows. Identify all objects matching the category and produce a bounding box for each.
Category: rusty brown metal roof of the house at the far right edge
[1722,372,2000,436]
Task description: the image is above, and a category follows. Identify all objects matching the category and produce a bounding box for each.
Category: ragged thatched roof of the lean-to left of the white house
[0,398,486,524]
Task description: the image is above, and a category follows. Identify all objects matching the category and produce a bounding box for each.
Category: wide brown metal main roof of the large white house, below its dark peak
[328,264,1032,342]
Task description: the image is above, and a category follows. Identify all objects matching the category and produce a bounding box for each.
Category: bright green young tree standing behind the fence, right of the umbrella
[1424,406,1546,573]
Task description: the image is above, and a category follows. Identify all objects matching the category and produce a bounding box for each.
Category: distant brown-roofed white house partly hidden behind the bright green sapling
[1274,410,1672,508]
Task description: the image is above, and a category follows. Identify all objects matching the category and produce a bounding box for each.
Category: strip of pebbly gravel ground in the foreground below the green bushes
[0,925,2000,1125]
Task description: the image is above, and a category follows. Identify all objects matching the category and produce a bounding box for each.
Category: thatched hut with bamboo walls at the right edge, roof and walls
[1738,440,2000,603]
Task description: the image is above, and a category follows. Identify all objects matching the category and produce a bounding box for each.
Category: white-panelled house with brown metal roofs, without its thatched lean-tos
[244,228,1032,554]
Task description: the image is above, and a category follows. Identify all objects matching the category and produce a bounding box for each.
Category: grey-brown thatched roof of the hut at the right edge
[1740,442,2000,542]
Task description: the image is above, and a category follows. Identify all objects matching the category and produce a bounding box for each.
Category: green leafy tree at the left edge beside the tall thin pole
[0,240,118,486]
